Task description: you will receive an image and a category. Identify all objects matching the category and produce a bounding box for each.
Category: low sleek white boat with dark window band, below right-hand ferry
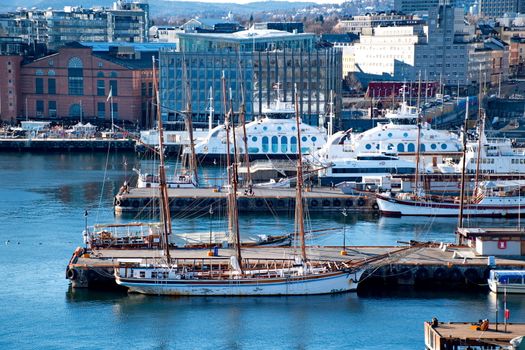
[319,153,416,186]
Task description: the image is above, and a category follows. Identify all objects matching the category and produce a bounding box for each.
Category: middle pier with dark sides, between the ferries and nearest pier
[114,187,378,215]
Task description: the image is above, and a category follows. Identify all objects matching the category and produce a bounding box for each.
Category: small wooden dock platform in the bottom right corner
[425,322,525,350]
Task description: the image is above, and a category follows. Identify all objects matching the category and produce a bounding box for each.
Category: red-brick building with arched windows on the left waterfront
[0,42,157,126]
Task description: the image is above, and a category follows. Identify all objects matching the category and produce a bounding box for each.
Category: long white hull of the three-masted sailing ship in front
[116,270,363,296]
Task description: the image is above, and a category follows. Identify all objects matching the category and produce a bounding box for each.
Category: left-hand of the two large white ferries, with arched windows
[188,101,327,163]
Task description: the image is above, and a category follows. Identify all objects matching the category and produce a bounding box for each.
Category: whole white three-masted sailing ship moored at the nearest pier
[115,85,364,296]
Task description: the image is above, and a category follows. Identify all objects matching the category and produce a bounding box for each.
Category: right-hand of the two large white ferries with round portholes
[313,102,462,164]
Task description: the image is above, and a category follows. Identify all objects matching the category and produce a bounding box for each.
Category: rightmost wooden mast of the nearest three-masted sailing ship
[295,85,306,262]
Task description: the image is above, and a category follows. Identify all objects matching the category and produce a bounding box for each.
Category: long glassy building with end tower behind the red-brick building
[0,0,150,50]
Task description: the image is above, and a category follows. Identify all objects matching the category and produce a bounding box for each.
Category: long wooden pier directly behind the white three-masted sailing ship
[67,244,525,290]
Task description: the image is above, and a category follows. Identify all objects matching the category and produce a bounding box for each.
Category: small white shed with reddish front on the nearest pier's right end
[456,227,525,256]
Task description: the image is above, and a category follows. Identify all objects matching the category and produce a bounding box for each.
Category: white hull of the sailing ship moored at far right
[376,195,525,217]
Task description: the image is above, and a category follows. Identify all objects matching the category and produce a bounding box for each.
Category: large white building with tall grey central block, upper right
[355,5,509,86]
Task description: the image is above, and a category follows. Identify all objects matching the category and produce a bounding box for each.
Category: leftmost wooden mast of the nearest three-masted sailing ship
[152,57,172,265]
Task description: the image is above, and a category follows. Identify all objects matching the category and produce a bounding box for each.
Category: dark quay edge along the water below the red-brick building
[0,138,135,152]
